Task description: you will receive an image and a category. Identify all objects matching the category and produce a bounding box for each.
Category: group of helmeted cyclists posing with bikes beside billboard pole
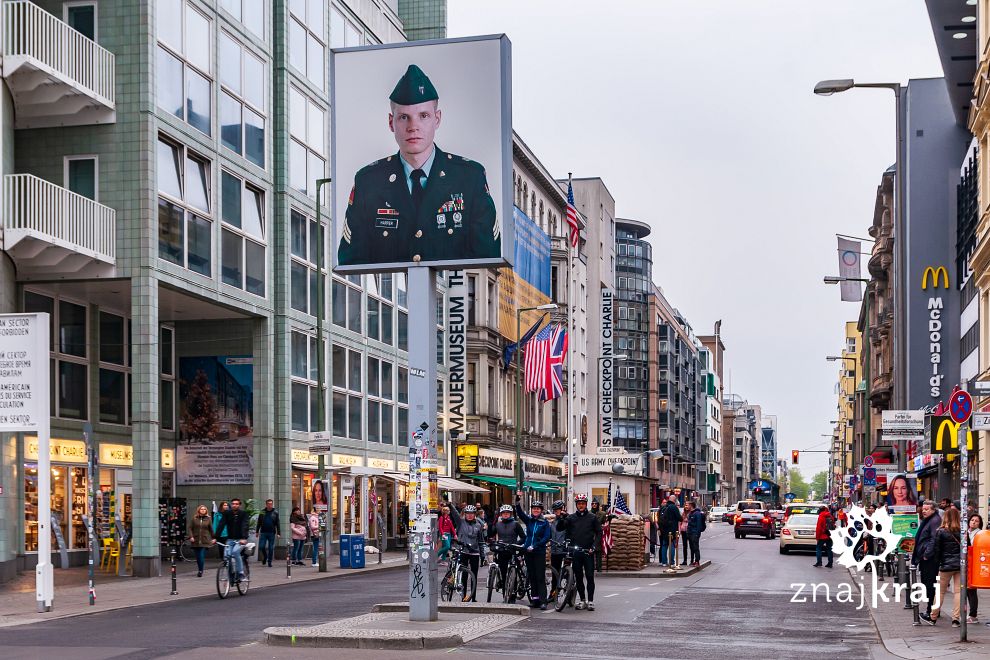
[440,491,602,610]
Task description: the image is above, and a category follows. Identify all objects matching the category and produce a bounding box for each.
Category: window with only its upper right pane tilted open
[220,171,266,296]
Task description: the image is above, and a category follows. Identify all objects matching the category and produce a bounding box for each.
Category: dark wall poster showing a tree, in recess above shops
[176,356,254,486]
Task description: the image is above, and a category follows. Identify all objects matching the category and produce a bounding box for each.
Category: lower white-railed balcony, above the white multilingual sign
[2,174,117,280]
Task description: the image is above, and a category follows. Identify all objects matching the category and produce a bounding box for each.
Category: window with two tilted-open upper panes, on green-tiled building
[156,138,212,277]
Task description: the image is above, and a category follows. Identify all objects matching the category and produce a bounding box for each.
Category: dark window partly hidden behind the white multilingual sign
[24,291,89,419]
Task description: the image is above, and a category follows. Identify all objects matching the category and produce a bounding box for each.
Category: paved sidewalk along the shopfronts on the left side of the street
[0,551,406,628]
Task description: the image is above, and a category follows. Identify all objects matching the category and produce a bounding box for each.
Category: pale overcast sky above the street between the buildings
[447,0,942,480]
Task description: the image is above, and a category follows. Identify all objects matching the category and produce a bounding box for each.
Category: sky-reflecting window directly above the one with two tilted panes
[156,0,213,135]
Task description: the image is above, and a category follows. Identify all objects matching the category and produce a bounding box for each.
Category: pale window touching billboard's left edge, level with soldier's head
[289,87,327,198]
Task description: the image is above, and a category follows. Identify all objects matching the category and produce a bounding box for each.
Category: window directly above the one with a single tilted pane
[219,32,268,168]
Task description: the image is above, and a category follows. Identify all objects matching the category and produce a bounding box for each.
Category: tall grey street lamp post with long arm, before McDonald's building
[815,78,907,410]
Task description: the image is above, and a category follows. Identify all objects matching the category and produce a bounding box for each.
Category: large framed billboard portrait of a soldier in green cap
[331,35,513,273]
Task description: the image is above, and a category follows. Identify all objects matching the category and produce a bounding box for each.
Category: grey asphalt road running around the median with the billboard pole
[0,523,883,660]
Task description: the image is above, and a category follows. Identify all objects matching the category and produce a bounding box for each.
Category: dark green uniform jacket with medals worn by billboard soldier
[338,147,502,266]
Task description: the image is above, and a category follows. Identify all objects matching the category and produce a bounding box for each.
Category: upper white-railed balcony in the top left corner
[3,0,116,128]
